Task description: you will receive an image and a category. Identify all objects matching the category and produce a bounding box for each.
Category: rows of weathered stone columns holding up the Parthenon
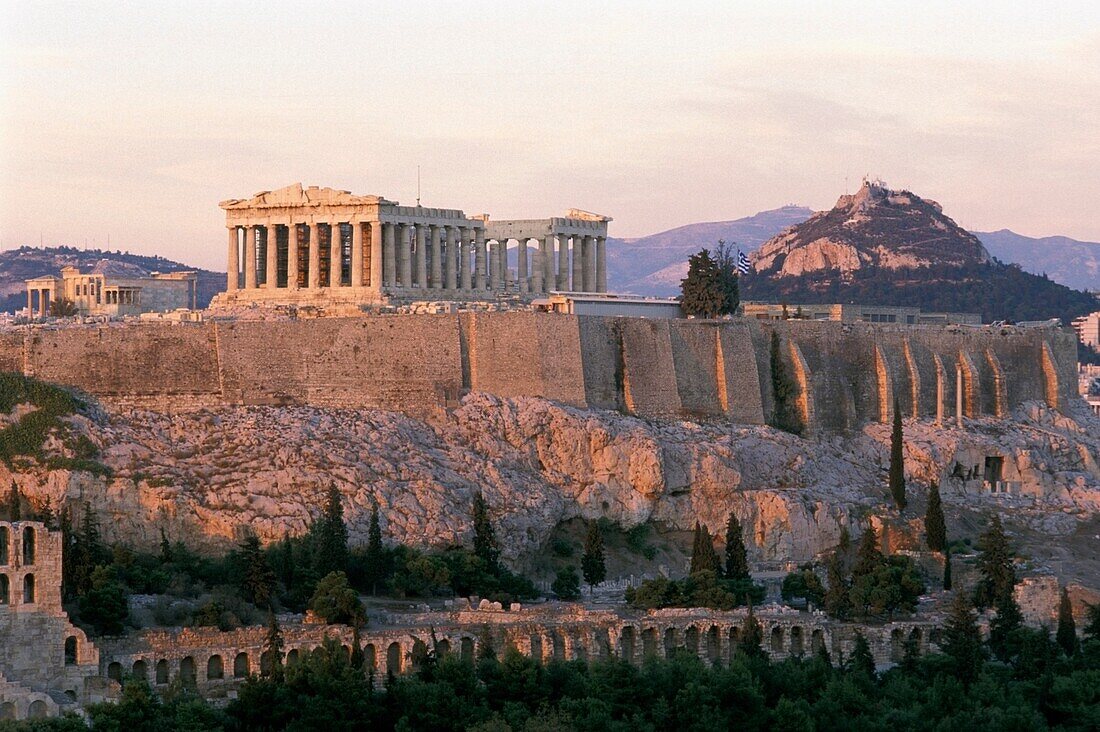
[227,222,607,293]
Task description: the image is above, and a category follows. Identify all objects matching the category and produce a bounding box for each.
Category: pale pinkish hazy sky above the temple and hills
[0,0,1100,267]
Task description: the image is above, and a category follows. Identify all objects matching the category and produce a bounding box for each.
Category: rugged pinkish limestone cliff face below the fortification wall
[0,393,1100,576]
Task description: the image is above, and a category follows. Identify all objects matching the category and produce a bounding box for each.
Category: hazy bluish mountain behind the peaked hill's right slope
[975,229,1100,291]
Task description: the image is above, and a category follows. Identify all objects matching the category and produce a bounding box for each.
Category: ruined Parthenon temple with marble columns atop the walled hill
[220,183,612,305]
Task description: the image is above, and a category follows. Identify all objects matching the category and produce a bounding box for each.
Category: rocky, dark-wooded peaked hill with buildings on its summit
[741,182,1097,321]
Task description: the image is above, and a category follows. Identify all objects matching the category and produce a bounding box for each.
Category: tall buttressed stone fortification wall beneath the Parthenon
[0,312,1077,431]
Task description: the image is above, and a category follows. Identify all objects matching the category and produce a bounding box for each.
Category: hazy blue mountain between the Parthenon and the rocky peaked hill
[607,206,813,297]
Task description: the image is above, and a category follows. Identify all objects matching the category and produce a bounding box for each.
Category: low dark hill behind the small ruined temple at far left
[0,247,226,313]
